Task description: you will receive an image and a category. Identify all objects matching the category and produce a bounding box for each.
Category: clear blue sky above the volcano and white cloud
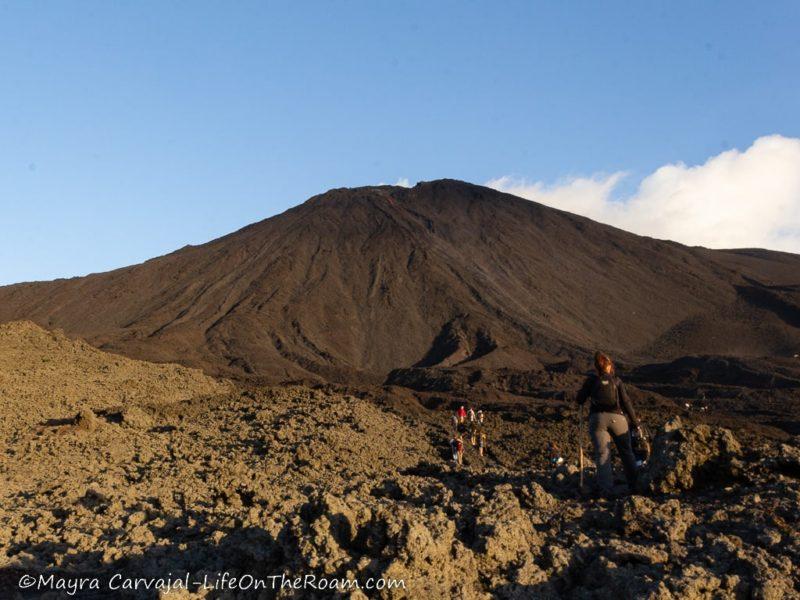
[0,1,800,284]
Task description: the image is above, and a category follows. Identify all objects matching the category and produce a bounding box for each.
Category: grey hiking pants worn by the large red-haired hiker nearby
[589,412,636,494]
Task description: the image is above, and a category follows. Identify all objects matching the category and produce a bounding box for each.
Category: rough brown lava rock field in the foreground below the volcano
[0,329,800,599]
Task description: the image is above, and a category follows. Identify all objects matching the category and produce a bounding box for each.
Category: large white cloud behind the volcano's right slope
[486,135,800,253]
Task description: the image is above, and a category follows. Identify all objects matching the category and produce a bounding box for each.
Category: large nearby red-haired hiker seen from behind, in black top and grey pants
[576,352,641,495]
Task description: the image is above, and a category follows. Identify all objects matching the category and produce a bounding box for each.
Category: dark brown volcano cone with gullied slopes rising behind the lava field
[0,180,800,382]
